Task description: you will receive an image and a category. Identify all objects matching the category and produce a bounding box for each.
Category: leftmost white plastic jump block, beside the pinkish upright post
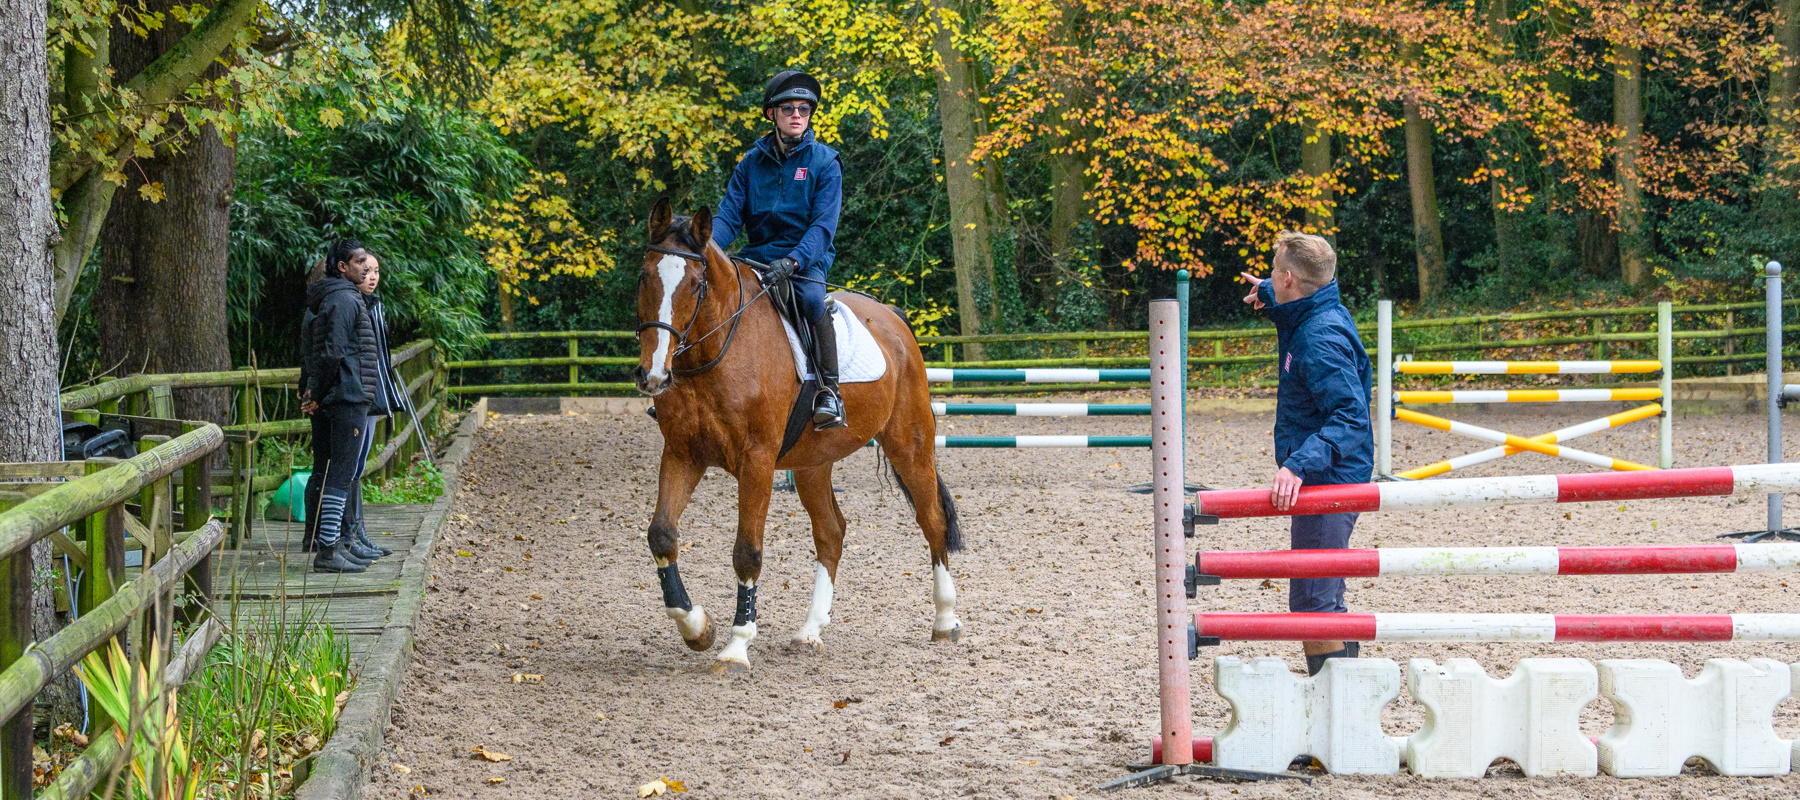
[1213,656,1404,775]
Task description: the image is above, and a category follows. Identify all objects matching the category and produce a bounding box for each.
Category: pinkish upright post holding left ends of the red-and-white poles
[1150,299,1193,766]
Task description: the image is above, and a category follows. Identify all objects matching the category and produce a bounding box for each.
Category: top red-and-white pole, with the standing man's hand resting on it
[1199,463,1800,517]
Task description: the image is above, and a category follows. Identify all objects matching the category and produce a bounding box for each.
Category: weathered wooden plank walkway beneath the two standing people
[214,505,432,667]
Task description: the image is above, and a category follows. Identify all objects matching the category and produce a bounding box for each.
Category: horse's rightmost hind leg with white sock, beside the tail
[882,428,963,641]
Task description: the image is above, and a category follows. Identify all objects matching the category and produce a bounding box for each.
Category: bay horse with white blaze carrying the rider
[632,198,961,672]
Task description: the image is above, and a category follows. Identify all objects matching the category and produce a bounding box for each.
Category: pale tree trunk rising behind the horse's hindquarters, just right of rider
[931,0,994,360]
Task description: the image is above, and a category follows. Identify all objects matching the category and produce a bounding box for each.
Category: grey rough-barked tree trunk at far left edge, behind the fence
[0,2,70,731]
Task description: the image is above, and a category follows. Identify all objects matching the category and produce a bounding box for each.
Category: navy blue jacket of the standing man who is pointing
[1256,281,1375,486]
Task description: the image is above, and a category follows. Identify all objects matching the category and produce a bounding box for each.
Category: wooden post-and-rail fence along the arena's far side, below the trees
[445,299,1800,396]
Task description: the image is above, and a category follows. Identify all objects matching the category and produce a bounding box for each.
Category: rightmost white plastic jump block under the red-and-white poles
[1600,658,1793,778]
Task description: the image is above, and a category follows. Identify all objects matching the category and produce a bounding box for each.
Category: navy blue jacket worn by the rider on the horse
[713,130,844,272]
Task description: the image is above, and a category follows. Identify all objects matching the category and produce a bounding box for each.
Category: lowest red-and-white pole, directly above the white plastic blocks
[1193,613,1800,641]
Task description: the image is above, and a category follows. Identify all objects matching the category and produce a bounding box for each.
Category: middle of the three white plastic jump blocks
[1406,658,1598,778]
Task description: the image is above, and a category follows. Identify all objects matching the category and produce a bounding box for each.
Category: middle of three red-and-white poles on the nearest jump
[1195,542,1800,580]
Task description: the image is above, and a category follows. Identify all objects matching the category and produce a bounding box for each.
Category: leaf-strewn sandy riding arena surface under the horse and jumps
[365,403,1800,798]
